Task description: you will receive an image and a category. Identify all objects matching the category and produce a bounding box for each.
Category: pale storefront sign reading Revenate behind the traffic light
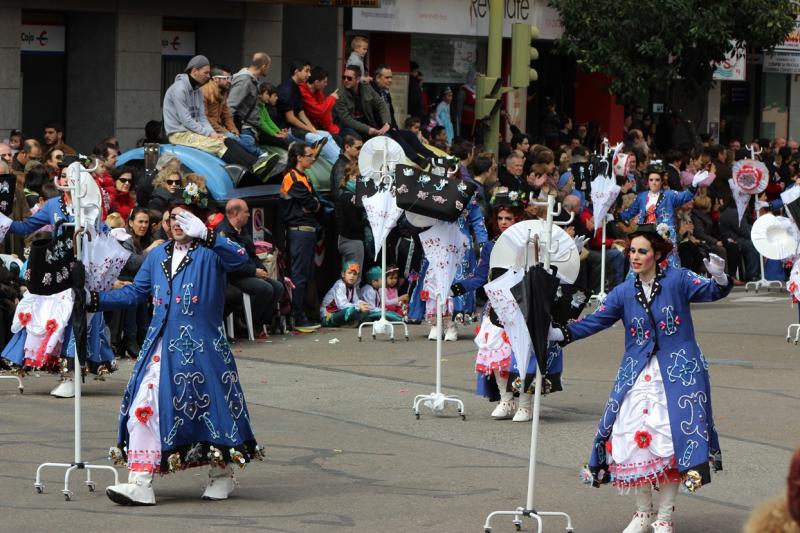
[353,0,563,40]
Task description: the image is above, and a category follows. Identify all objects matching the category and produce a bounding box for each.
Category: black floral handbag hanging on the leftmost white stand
[25,220,75,296]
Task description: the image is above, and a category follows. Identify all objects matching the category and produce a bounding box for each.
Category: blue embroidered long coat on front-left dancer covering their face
[89,231,257,472]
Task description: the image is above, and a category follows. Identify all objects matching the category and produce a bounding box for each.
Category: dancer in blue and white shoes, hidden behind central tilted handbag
[408,166,489,341]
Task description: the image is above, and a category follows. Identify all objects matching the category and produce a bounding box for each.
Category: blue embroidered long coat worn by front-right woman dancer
[562,267,733,488]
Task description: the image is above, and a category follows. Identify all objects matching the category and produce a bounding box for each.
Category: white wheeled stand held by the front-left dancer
[33,163,119,501]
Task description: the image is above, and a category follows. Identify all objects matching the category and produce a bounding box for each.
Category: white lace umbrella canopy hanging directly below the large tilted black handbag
[419,221,469,297]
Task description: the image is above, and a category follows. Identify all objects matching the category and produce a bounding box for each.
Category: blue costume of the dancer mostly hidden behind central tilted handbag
[408,195,491,320]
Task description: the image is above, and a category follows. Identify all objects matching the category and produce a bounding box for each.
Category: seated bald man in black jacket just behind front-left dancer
[217,198,283,339]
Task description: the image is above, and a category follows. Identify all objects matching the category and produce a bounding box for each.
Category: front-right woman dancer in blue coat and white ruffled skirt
[549,224,732,533]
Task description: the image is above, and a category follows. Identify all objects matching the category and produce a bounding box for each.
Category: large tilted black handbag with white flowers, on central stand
[395,165,475,222]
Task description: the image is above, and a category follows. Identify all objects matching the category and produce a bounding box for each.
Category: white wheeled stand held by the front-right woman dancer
[483,195,574,533]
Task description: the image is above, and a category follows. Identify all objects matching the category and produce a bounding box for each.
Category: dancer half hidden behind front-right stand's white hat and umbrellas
[472,187,563,422]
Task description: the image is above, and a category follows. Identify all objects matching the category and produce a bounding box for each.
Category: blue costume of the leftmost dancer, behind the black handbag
[0,197,116,373]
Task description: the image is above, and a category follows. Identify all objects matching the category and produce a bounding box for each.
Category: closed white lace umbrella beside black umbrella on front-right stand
[483,267,532,376]
